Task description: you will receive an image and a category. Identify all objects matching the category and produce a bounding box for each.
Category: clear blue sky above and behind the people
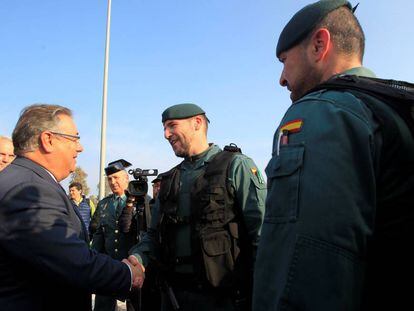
[0,0,414,193]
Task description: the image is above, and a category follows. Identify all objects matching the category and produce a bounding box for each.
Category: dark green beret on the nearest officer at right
[276,0,352,58]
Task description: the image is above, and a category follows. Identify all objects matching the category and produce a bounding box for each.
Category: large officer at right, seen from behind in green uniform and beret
[253,0,414,311]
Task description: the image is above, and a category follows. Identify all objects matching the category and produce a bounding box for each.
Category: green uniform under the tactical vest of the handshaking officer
[130,145,266,310]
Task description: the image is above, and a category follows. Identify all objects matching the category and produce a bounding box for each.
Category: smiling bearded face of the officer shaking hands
[164,118,195,158]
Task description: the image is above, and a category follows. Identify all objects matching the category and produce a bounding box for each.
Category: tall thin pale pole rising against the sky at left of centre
[99,0,112,200]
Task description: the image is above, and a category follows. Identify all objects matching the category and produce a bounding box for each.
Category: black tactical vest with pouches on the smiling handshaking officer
[158,146,253,288]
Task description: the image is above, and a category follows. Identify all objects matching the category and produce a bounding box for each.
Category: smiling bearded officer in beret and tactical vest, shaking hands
[131,104,266,311]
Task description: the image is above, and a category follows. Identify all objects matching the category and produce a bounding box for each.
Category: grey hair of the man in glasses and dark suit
[12,104,72,155]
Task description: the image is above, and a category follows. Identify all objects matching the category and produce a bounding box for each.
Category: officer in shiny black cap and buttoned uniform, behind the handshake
[91,159,138,311]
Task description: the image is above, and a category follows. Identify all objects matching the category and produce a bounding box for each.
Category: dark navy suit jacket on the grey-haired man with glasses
[0,157,131,311]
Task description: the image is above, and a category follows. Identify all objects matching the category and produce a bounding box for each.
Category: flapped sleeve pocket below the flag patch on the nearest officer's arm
[264,144,305,223]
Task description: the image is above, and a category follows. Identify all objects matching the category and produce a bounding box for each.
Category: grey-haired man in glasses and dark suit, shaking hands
[0,105,142,311]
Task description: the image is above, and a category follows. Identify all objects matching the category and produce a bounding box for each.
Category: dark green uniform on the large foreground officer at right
[253,67,414,311]
